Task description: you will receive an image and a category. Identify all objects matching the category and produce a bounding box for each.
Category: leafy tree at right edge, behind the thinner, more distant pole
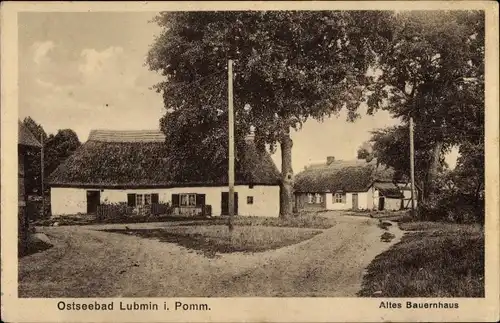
[365,11,484,199]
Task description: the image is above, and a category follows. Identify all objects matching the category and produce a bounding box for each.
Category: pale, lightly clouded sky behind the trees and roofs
[18,12,456,172]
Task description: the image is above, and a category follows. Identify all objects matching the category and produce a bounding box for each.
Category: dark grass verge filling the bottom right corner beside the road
[358,222,484,297]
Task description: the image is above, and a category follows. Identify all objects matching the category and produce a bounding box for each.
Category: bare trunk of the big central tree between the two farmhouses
[280,129,294,218]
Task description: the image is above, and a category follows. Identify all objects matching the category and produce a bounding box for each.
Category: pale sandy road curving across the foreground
[19,212,402,297]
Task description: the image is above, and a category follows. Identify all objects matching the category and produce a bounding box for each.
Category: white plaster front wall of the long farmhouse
[51,185,280,217]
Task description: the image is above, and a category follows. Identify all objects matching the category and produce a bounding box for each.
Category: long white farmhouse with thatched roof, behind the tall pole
[48,130,279,217]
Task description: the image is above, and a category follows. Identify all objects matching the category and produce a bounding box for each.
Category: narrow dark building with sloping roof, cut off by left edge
[17,121,42,248]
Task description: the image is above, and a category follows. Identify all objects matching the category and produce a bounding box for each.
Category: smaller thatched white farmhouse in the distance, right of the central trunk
[294,157,411,210]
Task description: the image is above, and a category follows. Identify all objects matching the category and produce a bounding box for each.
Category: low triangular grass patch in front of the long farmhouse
[102,225,322,257]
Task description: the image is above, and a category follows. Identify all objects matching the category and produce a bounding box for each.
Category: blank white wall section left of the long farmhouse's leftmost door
[50,187,87,215]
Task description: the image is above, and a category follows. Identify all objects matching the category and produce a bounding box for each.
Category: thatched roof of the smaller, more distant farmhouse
[294,160,394,193]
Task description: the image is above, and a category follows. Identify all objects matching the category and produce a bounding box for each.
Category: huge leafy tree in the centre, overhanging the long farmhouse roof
[147,11,390,217]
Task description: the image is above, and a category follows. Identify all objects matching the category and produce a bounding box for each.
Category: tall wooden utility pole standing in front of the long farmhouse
[227,60,234,231]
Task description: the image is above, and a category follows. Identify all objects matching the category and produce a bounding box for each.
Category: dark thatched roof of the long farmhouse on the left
[48,130,279,188]
